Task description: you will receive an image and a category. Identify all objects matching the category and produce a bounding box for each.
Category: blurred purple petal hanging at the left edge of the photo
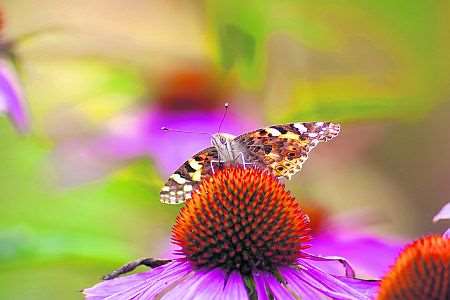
[0,59,28,132]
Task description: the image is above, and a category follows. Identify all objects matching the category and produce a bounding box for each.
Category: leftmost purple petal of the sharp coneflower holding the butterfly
[83,261,192,300]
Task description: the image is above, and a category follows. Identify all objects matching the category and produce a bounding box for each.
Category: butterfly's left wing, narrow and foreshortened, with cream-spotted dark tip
[159,147,218,204]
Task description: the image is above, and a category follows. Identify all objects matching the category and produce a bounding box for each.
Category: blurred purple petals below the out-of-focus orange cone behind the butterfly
[54,105,258,185]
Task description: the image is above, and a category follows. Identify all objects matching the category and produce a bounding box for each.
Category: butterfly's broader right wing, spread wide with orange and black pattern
[235,122,340,179]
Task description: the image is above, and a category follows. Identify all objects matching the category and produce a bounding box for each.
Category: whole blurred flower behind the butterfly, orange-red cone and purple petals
[54,67,259,185]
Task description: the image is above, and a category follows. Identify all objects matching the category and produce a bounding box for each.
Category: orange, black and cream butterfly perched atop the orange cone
[160,122,340,204]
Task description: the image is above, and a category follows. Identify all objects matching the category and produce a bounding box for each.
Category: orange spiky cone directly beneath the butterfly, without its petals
[172,167,310,274]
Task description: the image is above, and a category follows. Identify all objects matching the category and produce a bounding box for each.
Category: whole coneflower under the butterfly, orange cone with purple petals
[84,167,378,300]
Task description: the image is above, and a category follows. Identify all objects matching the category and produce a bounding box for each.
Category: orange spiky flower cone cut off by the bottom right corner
[377,235,450,300]
